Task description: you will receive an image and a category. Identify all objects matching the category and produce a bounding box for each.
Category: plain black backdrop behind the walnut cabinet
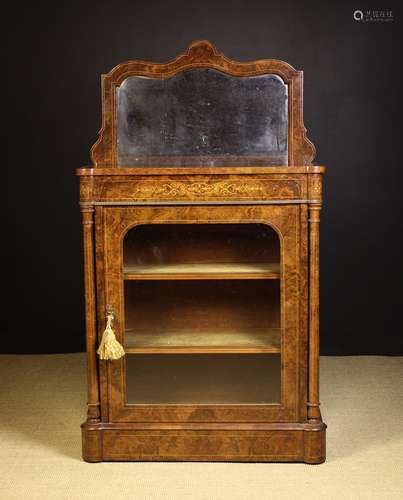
[0,0,403,354]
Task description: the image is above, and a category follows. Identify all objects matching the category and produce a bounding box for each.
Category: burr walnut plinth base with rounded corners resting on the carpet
[81,421,326,464]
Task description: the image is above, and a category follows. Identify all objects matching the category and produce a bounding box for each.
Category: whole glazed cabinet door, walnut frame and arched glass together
[97,205,306,422]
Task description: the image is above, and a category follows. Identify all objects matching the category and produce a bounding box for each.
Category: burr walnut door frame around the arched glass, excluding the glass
[97,205,306,422]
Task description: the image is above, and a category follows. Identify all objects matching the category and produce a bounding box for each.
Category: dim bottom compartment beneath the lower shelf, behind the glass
[125,354,281,405]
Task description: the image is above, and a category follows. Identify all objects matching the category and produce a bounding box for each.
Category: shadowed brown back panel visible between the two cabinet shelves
[125,280,280,334]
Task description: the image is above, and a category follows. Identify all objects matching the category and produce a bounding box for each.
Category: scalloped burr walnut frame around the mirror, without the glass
[91,40,315,168]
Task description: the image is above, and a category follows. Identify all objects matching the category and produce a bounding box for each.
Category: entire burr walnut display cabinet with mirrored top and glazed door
[77,41,326,463]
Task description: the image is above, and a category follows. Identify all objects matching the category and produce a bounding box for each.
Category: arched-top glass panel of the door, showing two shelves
[123,224,281,404]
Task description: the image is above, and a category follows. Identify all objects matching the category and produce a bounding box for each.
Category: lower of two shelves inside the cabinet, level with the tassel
[125,328,281,354]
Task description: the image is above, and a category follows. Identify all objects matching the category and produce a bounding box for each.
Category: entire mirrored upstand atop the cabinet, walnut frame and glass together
[91,40,315,169]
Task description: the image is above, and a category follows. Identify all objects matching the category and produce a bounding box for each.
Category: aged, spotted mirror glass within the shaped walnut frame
[117,68,288,167]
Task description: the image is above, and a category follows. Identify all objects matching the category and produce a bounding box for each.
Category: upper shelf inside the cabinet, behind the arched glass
[123,262,280,280]
